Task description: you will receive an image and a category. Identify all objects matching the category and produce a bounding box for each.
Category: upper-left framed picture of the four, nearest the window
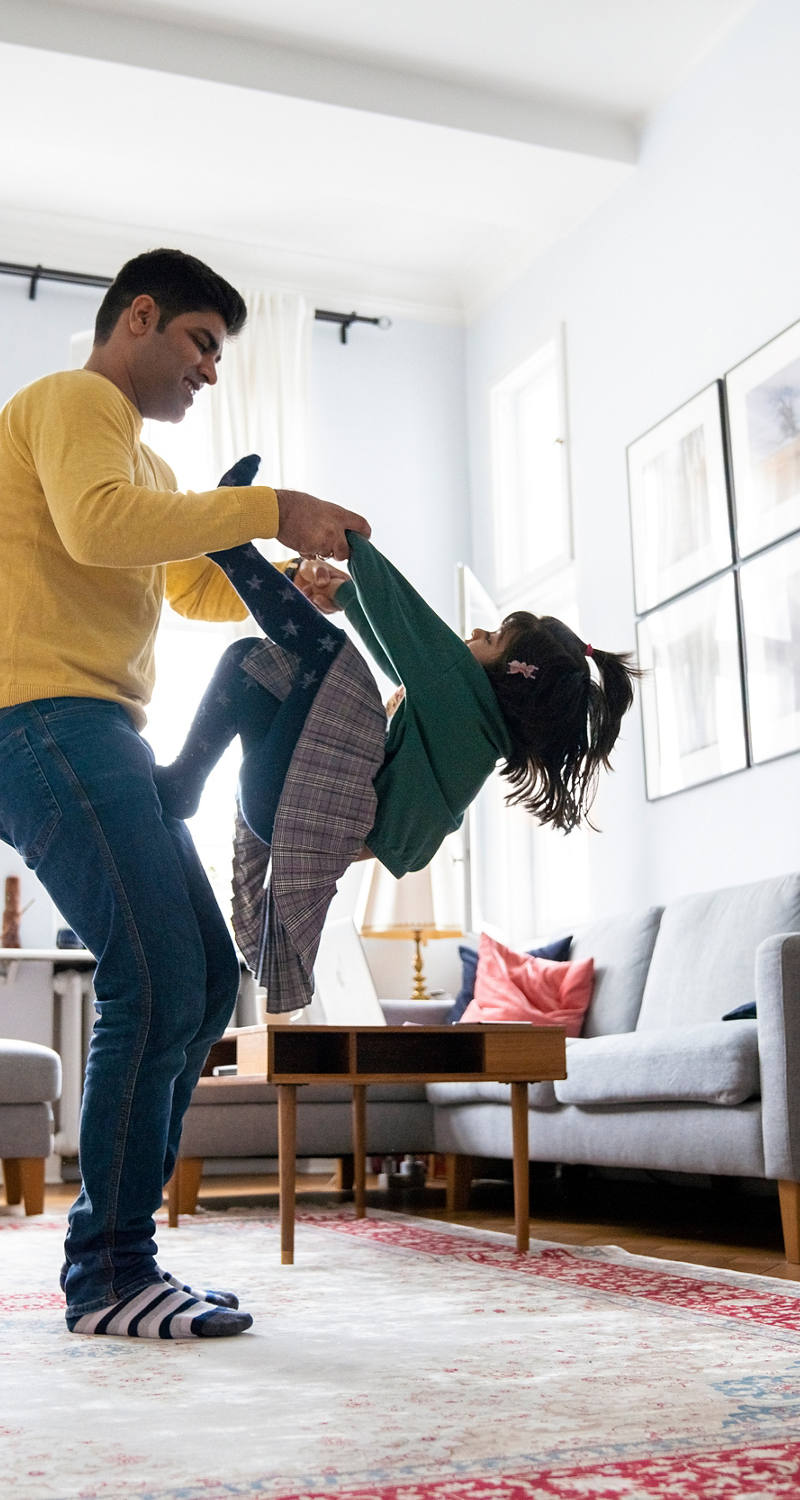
[627,381,732,614]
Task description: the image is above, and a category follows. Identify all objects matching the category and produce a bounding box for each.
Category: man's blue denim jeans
[0,698,239,1314]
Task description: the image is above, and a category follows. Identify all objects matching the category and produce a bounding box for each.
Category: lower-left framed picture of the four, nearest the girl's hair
[636,573,747,800]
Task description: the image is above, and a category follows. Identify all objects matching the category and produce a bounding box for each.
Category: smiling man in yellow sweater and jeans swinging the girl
[0,251,369,1338]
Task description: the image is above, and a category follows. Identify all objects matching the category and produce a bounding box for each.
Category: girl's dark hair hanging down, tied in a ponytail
[486,611,641,833]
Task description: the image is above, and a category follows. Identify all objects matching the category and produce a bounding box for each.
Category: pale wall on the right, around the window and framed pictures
[467,0,800,914]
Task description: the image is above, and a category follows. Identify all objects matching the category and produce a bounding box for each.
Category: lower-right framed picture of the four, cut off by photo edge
[740,537,800,761]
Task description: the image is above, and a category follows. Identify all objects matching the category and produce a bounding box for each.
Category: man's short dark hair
[95,251,248,344]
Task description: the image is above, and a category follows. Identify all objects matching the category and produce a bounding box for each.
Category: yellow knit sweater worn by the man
[0,371,278,728]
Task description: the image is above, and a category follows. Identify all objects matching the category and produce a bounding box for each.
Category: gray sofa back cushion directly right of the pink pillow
[570,906,662,1037]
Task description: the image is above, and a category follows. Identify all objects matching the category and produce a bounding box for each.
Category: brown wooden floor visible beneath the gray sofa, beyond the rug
[40,1172,800,1281]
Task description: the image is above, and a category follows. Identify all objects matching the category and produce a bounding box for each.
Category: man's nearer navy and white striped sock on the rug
[66,1281,252,1338]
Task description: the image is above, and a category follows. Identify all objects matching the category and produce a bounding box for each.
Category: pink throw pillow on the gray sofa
[461,933,594,1037]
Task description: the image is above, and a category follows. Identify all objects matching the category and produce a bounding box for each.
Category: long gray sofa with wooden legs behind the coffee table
[173,875,800,1263]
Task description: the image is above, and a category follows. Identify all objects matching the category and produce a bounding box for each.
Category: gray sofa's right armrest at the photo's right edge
[753,933,800,1182]
